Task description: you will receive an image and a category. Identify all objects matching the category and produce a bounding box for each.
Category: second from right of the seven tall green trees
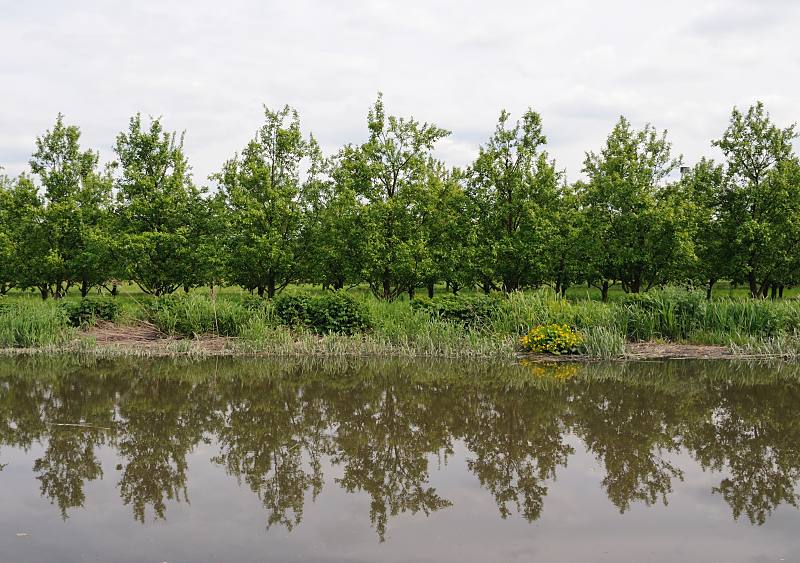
[578,117,691,301]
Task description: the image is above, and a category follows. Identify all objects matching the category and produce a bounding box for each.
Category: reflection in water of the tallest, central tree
[332,380,452,541]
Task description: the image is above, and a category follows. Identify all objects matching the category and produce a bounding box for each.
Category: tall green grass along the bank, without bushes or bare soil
[0,287,800,359]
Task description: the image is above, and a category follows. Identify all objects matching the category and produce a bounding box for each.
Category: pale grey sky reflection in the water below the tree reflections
[0,360,800,563]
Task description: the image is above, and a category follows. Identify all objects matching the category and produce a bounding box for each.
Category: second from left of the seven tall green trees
[115,114,197,296]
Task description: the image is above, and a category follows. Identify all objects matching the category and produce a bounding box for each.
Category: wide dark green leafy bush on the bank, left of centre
[275,291,372,334]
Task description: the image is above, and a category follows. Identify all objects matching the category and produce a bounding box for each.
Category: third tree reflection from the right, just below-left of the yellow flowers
[464,390,574,521]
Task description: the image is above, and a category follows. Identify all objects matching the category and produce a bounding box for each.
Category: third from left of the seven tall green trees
[214,106,308,298]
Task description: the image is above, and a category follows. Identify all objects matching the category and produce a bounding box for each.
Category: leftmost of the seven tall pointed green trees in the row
[30,114,113,298]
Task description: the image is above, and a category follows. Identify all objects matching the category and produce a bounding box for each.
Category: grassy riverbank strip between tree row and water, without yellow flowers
[0,289,800,361]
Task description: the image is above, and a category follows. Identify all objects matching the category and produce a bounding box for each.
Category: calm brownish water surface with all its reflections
[0,358,800,563]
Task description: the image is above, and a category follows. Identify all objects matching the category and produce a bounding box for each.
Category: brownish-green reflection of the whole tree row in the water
[0,362,800,539]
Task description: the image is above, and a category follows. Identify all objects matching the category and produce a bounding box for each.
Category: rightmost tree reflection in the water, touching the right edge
[686,385,800,524]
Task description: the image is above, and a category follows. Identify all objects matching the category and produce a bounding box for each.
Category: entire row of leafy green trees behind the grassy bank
[0,96,800,299]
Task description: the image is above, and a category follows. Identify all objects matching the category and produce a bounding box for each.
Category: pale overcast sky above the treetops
[0,0,800,184]
